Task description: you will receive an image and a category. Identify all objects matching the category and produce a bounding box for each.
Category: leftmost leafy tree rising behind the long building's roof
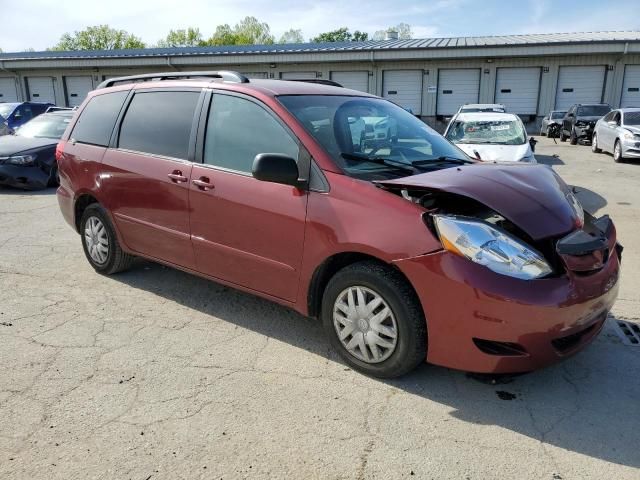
[50,25,145,50]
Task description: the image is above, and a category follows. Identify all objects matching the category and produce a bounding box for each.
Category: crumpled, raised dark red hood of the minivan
[376,163,580,240]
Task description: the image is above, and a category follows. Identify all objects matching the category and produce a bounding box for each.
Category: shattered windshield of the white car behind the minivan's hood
[447,119,527,145]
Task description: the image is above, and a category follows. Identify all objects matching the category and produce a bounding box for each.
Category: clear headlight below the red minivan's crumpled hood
[433,215,552,280]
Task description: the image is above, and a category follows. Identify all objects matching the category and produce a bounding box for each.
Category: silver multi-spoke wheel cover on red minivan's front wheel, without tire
[333,286,398,363]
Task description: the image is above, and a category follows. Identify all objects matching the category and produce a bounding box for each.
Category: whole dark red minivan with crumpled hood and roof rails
[56,72,622,377]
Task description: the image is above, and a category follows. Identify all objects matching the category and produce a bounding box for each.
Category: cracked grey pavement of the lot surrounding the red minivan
[0,139,640,480]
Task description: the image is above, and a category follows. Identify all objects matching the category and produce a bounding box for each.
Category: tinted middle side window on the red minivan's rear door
[118,91,200,160]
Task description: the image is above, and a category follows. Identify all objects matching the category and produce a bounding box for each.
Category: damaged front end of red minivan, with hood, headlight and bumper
[378,164,622,373]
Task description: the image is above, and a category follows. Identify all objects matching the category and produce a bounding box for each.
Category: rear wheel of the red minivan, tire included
[80,203,134,275]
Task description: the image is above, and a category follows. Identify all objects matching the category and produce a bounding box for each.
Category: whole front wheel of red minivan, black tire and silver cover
[321,261,427,378]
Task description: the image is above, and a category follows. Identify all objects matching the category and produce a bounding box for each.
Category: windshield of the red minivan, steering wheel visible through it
[278,95,473,180]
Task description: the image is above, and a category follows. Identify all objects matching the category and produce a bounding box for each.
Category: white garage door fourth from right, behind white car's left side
[436,68,480,115]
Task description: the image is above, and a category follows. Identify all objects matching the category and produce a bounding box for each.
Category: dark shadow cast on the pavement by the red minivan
[111,261,640,467]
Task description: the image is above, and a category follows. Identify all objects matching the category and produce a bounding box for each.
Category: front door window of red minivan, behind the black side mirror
[204,94,299,173]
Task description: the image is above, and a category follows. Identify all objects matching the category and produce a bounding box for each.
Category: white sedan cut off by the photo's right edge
[591,108,640,162]
